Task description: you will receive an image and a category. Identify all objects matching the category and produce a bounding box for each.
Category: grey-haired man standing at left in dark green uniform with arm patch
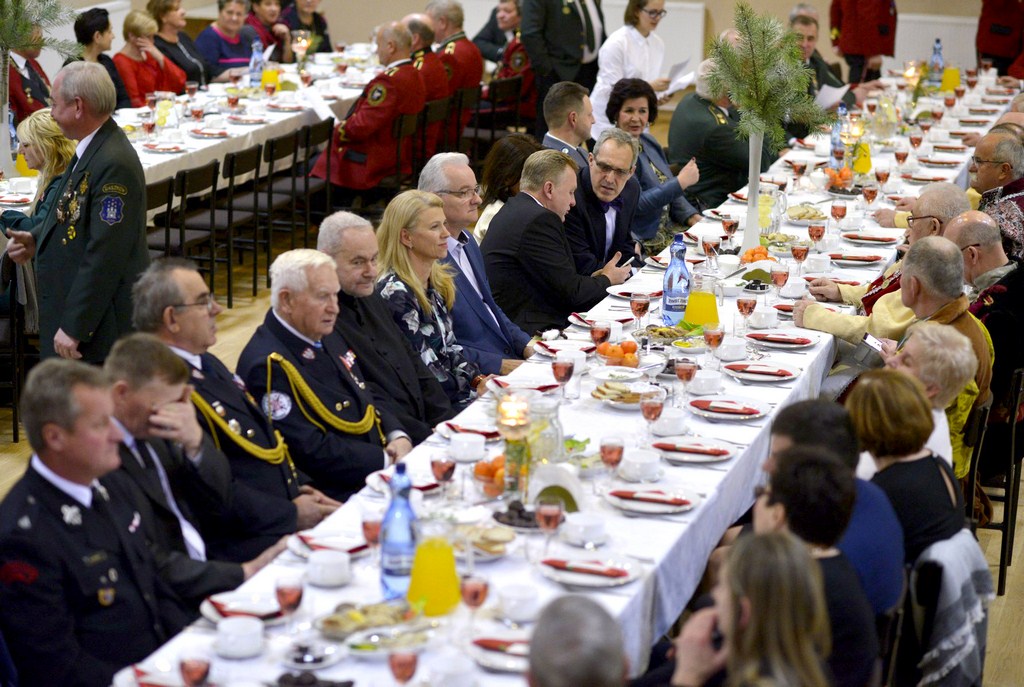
[8,61,150,362]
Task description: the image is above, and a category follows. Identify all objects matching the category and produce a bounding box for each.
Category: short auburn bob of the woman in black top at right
[846,370,935,459]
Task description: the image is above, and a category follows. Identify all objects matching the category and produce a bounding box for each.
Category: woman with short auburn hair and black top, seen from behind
[846,370,965,565]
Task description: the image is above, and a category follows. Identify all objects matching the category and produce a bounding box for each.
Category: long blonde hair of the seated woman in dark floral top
[377,189,455,312]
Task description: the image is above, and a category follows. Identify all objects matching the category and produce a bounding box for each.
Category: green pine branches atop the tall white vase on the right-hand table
[708,2,833,148]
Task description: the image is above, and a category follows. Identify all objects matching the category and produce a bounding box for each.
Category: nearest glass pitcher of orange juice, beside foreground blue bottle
[406,518,460,616]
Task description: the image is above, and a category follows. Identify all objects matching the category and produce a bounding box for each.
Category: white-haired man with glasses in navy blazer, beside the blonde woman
[419,153,534,375]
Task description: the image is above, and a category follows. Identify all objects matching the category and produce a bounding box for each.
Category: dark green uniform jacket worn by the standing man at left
[33,119,150,362]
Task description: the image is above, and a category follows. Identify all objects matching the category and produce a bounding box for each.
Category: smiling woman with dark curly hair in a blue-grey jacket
[605,79,700,249]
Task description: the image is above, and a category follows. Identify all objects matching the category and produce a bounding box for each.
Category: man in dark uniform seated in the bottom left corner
[0,360,188,687]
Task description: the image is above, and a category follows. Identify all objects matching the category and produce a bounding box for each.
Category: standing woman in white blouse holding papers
[590,0,669,139]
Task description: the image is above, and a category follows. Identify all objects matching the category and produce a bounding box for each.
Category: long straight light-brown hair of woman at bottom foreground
[724,532,831,687]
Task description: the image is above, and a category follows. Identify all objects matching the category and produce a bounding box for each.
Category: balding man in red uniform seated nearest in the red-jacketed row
[310,22,425,190]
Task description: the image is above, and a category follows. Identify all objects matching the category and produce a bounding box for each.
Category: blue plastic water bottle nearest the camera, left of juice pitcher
[381,463,416,600]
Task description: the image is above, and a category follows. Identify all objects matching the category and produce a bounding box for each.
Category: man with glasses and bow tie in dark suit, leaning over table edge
[565,128,642,274]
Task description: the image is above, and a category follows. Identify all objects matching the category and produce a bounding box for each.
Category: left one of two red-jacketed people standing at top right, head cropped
[828,0,896,84]
